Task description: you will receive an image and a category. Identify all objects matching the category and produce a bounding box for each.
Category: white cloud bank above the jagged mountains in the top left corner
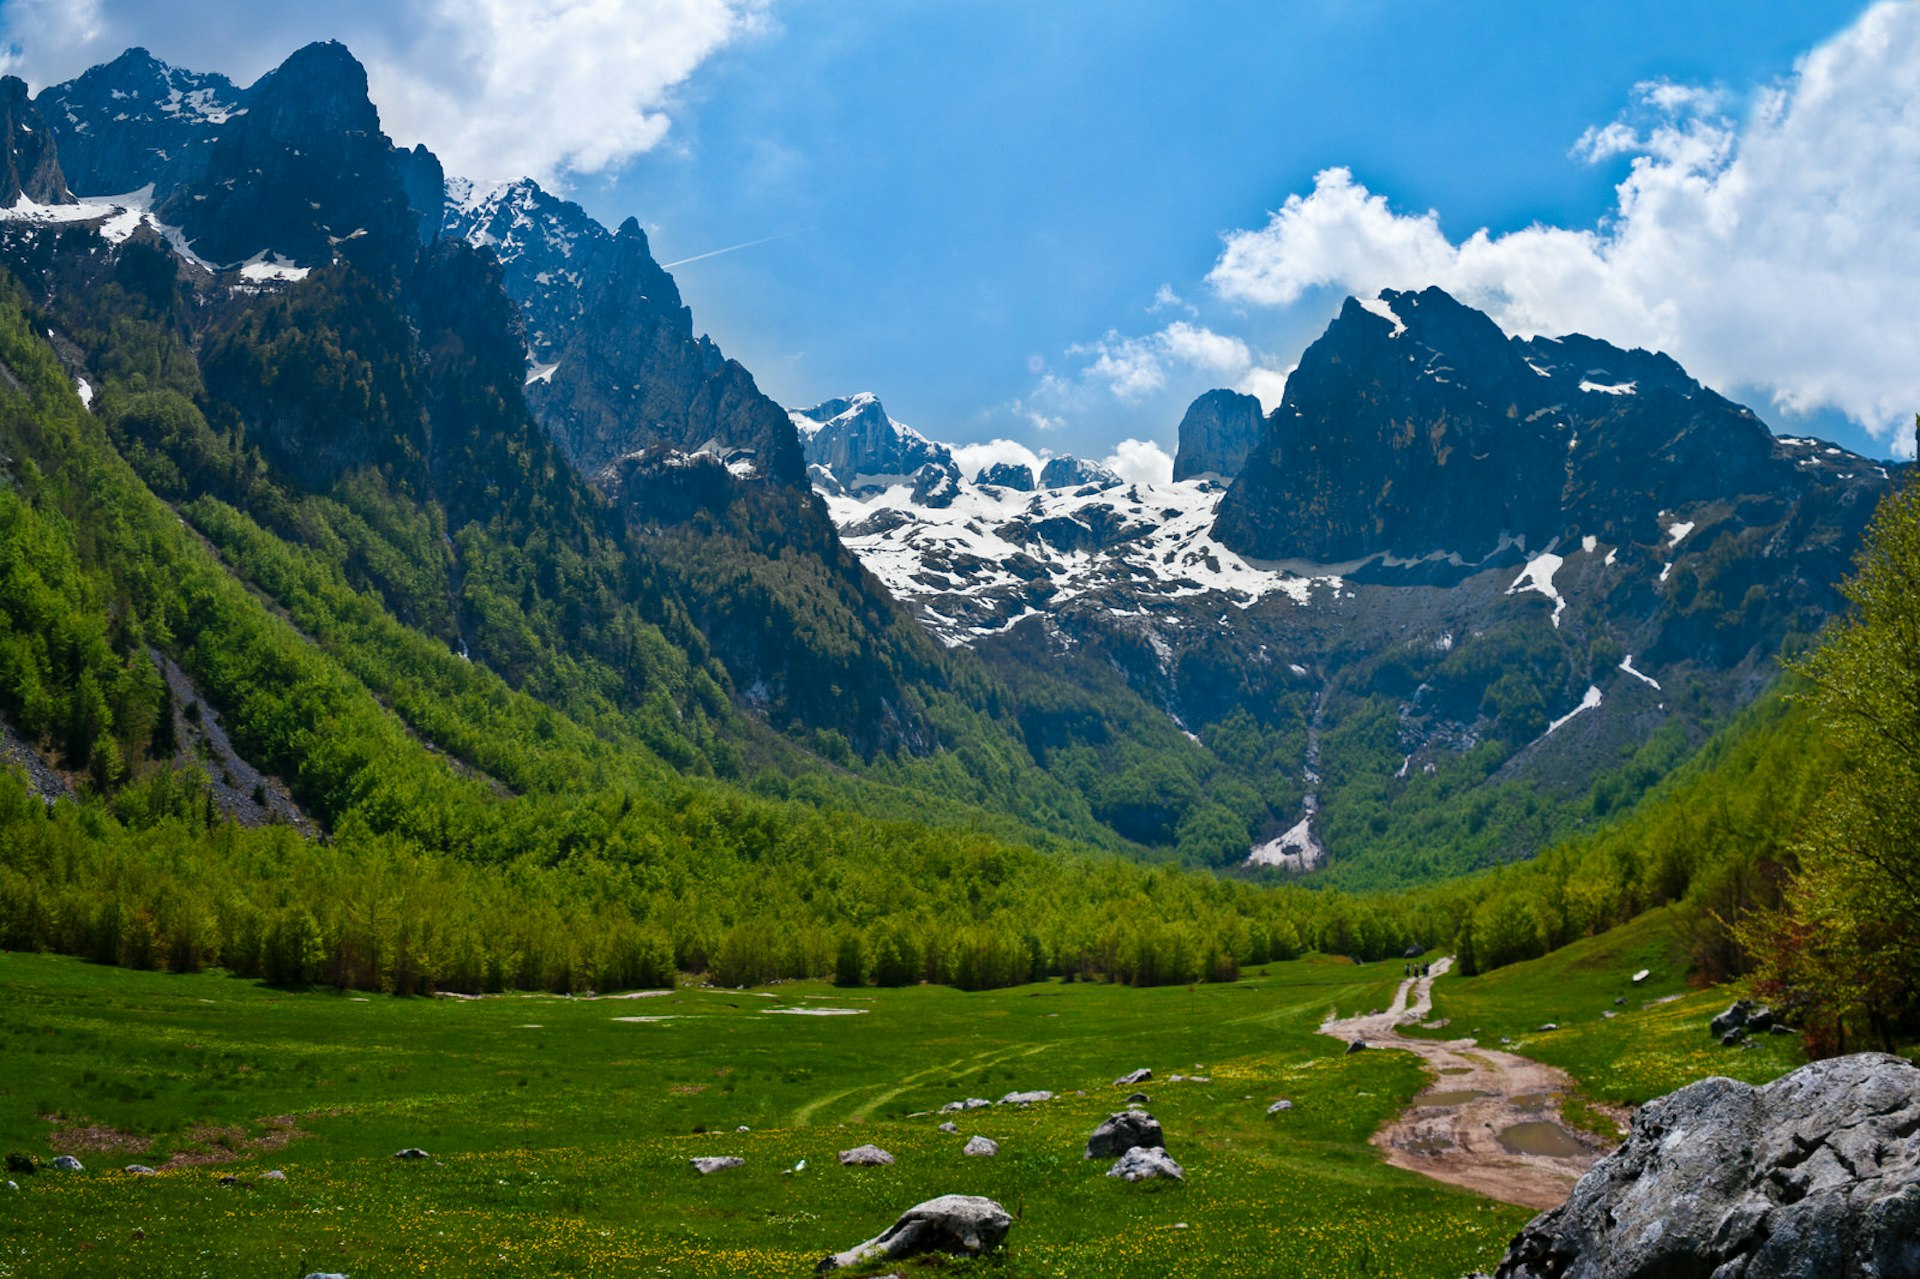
[0,0,766,186]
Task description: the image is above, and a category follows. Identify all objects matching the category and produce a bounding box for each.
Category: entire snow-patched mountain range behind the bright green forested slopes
[0,44,1893,887]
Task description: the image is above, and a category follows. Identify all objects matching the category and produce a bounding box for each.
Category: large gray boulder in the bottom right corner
[1496,1052,1920,1279]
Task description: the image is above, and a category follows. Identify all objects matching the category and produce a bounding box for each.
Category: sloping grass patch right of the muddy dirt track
[1411,908,1807,1137]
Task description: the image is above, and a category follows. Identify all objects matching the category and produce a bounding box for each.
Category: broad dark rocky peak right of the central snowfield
[1215,288,1791,565]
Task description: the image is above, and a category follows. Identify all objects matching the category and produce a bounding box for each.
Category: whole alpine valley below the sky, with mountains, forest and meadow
[0,29,1920,1279]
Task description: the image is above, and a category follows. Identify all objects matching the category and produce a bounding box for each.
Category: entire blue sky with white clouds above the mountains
[0,0,1920,478]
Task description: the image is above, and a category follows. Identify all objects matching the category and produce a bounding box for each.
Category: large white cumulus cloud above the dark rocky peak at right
[1208,0,1920,451]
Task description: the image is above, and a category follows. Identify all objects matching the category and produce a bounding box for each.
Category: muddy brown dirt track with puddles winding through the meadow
[1321,956,1624,1208]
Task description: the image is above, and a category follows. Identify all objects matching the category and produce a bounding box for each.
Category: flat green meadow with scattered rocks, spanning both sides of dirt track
[0,925,1791,1279]
